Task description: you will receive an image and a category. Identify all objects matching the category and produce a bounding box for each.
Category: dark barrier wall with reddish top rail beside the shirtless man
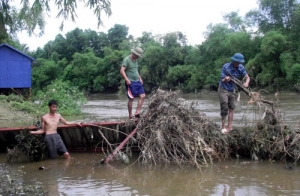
[0,122,135,152]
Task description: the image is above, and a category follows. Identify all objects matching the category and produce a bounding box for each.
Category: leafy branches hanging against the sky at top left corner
[0,0,111,42]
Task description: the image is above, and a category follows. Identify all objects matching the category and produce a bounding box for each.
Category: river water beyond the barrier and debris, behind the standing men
[79,92,300,126]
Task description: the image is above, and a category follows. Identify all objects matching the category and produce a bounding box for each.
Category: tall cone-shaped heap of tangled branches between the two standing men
[137,89,230,166]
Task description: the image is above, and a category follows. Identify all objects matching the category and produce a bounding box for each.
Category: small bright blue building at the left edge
[0,44,35,88]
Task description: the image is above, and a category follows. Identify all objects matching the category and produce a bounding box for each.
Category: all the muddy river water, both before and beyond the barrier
[0,93,300,196]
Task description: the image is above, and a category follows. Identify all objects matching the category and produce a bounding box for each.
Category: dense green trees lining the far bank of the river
[3,0,300,93]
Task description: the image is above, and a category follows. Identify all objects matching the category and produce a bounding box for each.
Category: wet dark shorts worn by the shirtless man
[45,133,68,158]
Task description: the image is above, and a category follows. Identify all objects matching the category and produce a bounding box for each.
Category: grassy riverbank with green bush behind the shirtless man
[0,88,86,126]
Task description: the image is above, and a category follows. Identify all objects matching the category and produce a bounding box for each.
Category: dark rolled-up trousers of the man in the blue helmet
[218,86,235,117]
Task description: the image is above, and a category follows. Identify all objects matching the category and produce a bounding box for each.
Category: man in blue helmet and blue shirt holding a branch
[218,53,250,134]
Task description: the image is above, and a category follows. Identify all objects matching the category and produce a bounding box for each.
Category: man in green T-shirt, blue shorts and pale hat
[120,47,146,119]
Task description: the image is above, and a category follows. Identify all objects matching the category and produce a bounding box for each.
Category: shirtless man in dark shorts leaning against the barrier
[30,100,81,159]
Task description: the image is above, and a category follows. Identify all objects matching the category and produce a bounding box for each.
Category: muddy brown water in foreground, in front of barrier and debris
[0,153,300,196]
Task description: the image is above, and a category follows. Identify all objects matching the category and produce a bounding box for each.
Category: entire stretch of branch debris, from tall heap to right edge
[127,89,300,167]
